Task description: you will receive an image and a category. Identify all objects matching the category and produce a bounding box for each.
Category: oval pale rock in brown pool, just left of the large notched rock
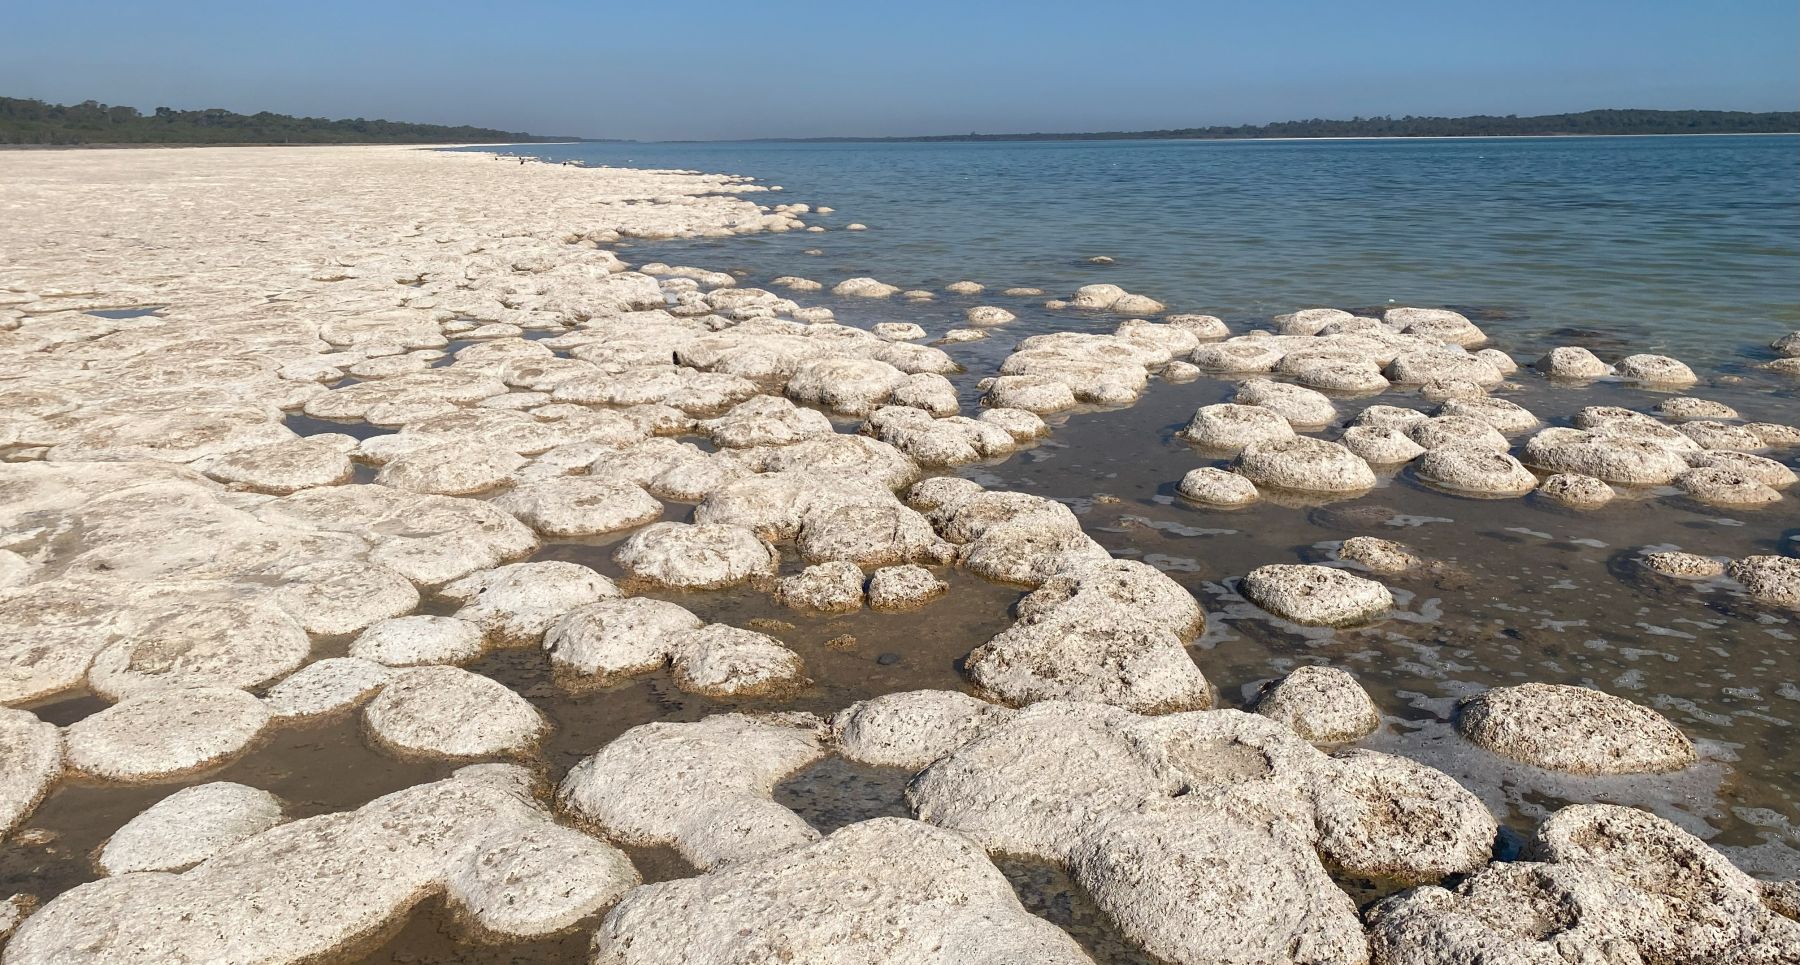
[362,666,549,758]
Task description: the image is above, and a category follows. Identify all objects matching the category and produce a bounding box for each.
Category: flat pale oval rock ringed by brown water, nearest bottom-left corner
[97,781,283,875]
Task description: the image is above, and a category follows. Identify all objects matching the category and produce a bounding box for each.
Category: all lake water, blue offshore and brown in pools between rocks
[0,139,1800,965]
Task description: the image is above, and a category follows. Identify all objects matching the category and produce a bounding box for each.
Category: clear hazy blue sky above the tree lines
[0,0,1800,140]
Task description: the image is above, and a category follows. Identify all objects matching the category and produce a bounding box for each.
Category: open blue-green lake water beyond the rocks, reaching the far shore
[468,135,1800,364]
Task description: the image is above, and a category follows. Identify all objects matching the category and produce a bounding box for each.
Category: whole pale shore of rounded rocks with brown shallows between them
[0,143,1800,965]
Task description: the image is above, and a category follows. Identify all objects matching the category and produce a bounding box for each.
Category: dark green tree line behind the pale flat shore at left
[0,97,580,144]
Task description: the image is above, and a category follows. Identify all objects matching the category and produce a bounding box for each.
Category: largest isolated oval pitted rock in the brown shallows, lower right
[1456,684,1697,774]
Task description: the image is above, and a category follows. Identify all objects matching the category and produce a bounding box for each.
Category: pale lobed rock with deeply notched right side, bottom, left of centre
[556,713,824,871]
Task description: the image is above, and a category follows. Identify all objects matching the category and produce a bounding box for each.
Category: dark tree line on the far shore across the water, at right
[759,110,1800,140]
